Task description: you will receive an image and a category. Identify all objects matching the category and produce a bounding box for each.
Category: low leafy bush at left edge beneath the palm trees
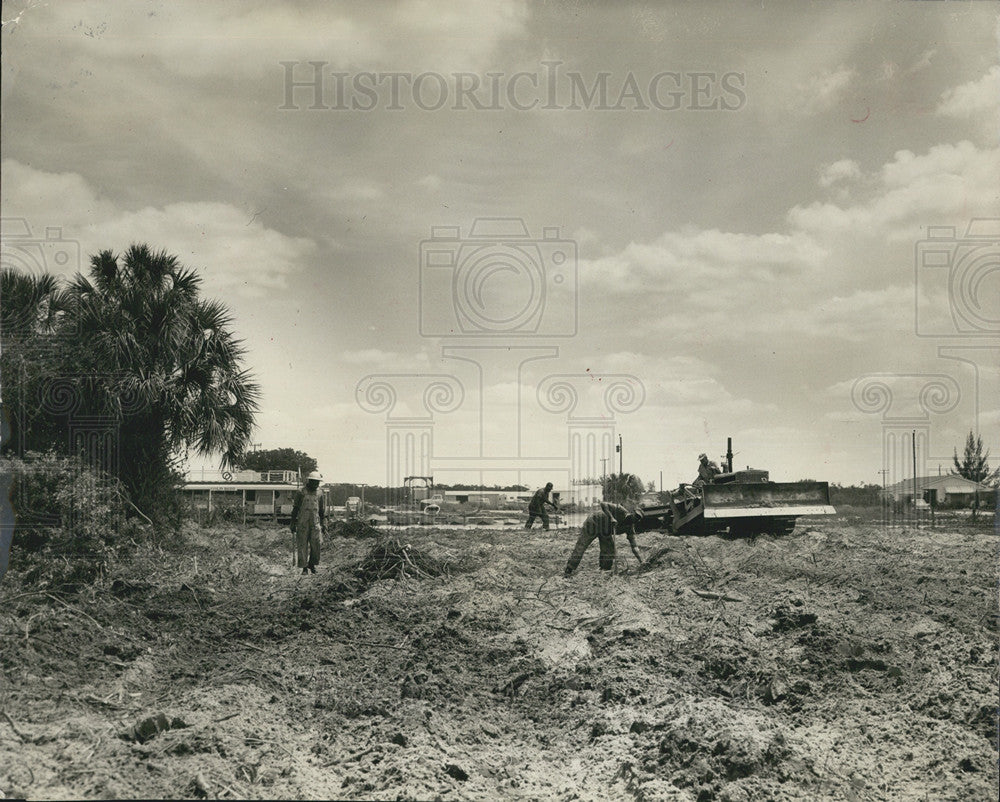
[3,452,152,586]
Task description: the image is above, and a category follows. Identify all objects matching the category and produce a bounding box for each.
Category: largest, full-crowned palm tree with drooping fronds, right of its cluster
[65,245,260,516]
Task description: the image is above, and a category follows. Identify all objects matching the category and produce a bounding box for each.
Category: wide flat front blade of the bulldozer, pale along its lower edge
[704,482,837,519]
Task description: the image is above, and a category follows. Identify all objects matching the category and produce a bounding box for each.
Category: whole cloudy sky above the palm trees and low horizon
[0,0,1000,488]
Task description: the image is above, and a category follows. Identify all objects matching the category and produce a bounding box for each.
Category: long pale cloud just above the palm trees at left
[0,159,316,296]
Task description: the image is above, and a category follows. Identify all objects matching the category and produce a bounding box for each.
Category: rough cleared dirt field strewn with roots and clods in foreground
[0,516,998,800]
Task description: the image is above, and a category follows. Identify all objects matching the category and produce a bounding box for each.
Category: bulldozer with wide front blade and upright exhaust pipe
[636,437,837,537]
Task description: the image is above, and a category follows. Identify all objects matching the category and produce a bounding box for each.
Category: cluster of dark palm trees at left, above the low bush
[0,245,260,528]
